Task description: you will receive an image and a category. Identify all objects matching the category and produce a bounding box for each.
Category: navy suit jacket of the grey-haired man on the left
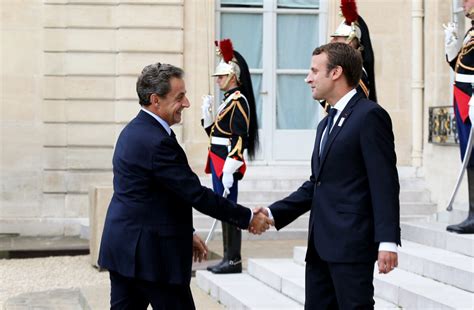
[99,111,250,284]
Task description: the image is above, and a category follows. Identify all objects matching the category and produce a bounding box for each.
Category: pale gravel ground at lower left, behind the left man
[0,255,109,305]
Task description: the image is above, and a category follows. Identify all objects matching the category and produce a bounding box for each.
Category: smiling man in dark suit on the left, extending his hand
[99,63,269,310]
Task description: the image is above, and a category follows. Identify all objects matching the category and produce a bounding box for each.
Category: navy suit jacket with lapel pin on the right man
[270,93,400,263]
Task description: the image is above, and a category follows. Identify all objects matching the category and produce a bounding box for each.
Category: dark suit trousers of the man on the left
[110,271,196,310]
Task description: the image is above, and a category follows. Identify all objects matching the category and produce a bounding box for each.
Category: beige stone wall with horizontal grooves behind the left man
[0,0,191,235]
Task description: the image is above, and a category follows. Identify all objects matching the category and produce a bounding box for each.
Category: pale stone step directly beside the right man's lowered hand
[398,240,474,293]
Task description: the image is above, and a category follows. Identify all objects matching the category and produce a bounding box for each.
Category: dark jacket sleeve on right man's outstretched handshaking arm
[269,176,315,230]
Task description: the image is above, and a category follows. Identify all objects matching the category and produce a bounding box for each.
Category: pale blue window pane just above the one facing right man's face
[277,14,319,69]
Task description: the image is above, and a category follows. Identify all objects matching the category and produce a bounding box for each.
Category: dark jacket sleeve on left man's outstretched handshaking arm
[152,138,251,229]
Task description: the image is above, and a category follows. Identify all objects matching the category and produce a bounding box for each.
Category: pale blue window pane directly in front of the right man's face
[276,74,319,129]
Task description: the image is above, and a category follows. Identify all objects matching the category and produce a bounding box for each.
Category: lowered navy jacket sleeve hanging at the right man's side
[360,107,400,244]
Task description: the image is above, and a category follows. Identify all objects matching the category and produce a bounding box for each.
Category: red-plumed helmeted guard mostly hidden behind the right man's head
[321,0,377,110]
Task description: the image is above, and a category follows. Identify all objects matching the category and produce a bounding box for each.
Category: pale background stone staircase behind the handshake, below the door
[193,165,436,240]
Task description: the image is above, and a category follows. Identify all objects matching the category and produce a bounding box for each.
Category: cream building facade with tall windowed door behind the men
[0,0,467,235]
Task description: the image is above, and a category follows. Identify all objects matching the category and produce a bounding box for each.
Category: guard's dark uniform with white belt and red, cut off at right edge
[448,21,474,167]
